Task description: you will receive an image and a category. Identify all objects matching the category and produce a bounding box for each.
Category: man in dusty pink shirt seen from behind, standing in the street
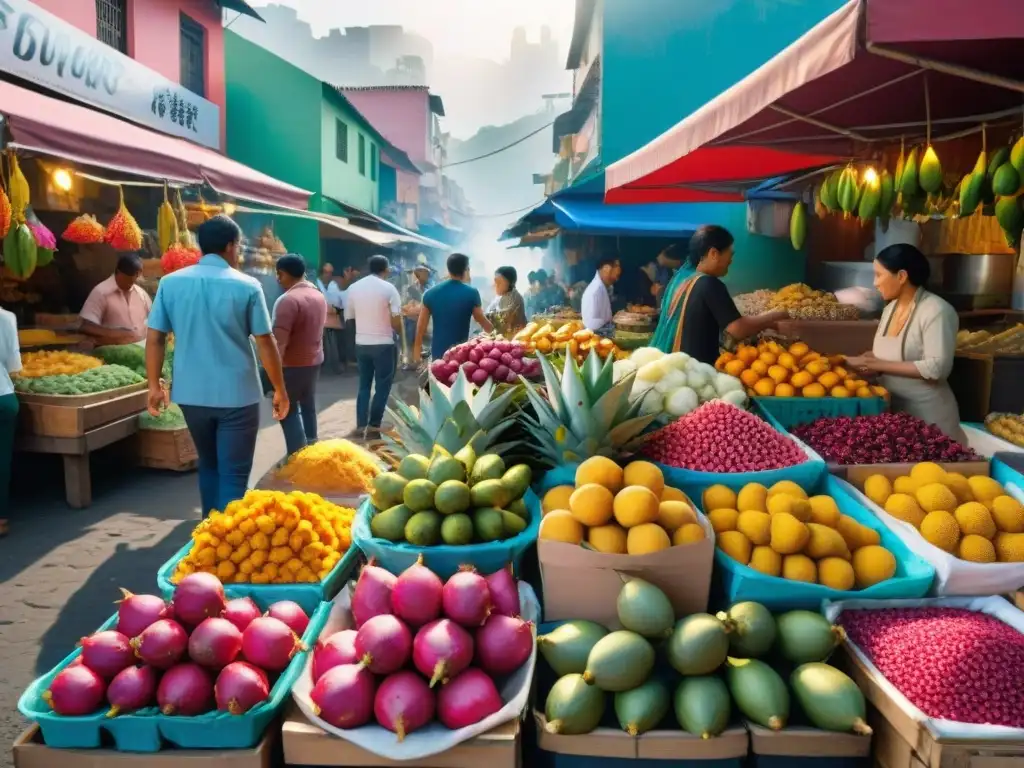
[273,253,327,456]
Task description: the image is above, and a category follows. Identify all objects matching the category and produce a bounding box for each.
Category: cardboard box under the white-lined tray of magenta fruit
[280,703,522,768]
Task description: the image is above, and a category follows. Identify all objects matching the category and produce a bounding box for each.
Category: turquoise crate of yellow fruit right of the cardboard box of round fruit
[708,474,935,610]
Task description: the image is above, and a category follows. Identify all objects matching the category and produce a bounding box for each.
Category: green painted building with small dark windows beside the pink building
[224,30,390,265]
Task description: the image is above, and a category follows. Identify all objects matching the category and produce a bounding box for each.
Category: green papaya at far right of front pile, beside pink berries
[790,662,871,736]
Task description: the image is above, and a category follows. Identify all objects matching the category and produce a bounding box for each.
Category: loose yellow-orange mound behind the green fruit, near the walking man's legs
[276,439,381,494]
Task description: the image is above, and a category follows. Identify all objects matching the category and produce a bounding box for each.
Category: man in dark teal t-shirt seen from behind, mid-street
[413,253,495,362]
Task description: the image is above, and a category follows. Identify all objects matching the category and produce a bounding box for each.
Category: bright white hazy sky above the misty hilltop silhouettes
[250,0,575,61]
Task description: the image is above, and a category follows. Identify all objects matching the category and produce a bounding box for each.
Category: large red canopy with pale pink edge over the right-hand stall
[605,0,1024,203]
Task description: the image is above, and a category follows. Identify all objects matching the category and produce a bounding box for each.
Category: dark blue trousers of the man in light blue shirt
[181,402,259,516]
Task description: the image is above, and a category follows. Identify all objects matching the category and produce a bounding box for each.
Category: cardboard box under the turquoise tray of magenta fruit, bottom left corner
[11,721,281,768]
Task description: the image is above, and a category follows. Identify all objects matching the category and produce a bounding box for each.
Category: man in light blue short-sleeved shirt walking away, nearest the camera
[145,216,289,515]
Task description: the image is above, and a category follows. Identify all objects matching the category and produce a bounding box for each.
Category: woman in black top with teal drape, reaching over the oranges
[651,224,788,366]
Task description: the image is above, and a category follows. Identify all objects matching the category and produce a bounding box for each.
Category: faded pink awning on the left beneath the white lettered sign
[0,82,311,209]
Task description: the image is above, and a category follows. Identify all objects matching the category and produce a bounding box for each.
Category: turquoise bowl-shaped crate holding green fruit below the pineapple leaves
[352,489,541,579]
